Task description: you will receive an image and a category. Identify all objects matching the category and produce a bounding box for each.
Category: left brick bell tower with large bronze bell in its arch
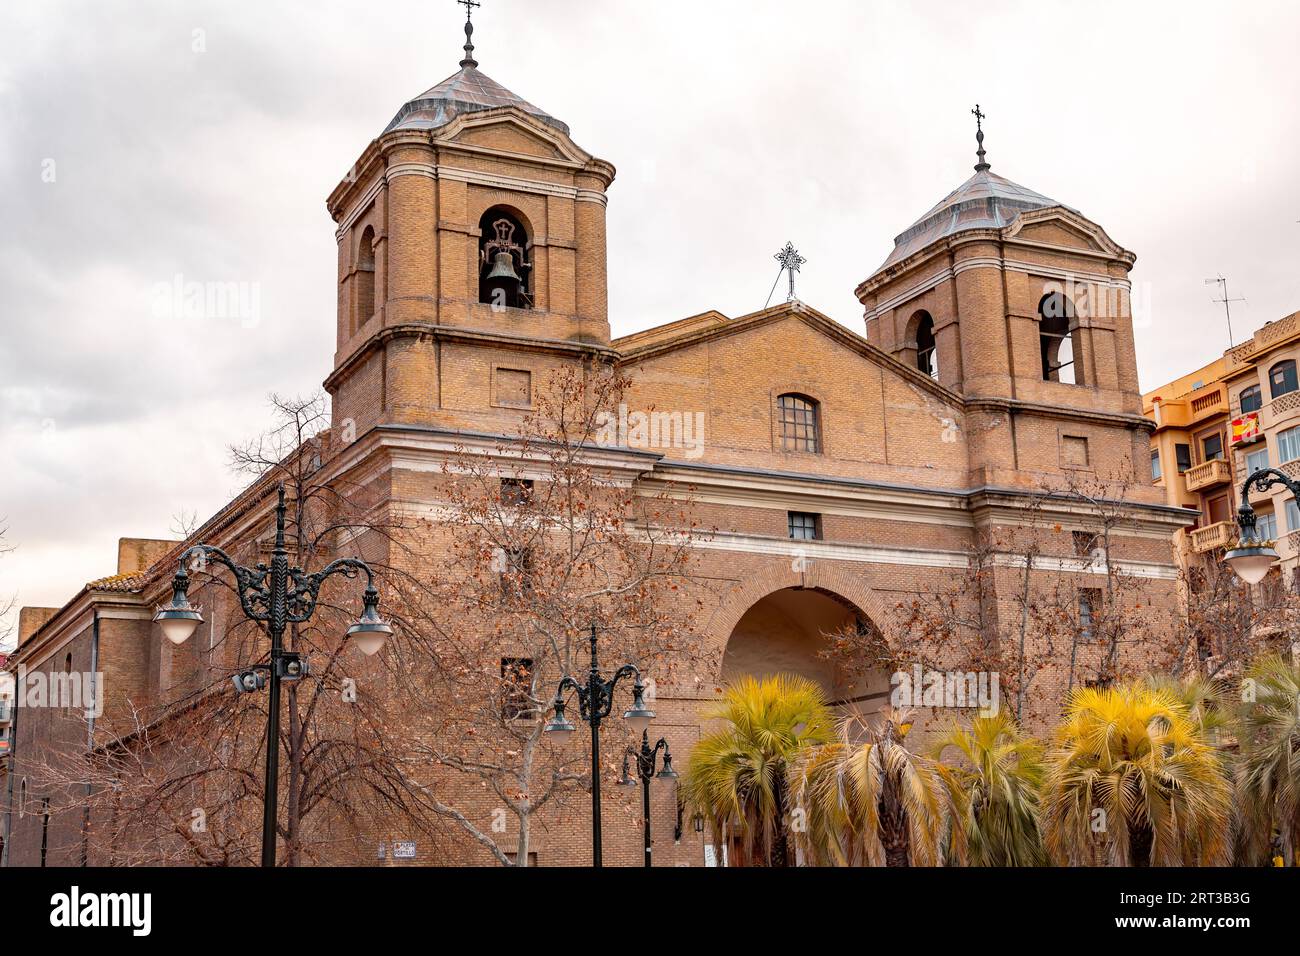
[325,4,614,429]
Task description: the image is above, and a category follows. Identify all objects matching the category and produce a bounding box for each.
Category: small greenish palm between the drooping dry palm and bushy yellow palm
[932,713,1048,866]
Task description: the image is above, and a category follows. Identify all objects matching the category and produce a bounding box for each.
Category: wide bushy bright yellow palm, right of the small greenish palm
[1043,683,1232,866]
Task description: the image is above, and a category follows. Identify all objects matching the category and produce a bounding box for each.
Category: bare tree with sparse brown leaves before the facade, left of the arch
[392,367,698,866]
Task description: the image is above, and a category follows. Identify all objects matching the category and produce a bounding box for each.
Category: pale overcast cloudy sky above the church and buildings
[0,0,1300,650]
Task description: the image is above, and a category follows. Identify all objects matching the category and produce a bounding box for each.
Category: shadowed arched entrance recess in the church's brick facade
[722,587,891,715]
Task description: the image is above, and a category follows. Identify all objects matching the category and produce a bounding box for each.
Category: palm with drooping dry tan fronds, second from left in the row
[796,710,949,866]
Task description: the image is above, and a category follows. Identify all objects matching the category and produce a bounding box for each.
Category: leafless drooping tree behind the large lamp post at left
[25,395,437,865]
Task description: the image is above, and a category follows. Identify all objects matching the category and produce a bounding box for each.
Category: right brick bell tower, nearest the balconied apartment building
[857,105,1149,486]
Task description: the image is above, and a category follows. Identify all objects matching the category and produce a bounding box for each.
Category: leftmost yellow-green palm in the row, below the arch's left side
[683,674,833,866]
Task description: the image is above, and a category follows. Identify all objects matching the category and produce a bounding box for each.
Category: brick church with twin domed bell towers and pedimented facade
[3,16,1187,865]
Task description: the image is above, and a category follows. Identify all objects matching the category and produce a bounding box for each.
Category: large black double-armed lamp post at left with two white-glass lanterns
[153,484,393,866]
